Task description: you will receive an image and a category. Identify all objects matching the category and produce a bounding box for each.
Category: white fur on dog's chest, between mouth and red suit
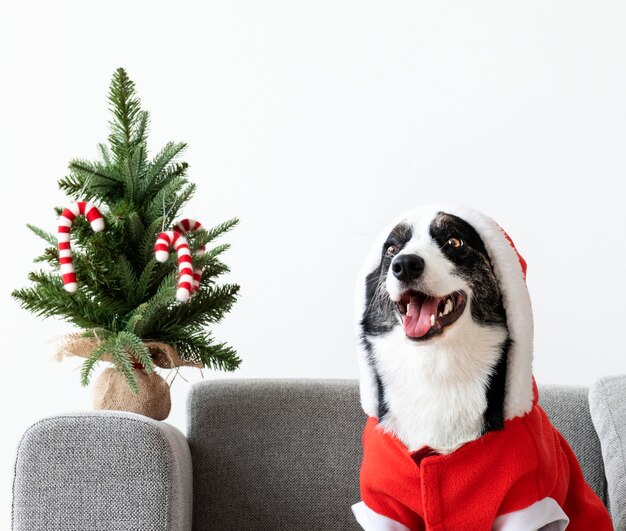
[372,322,506,453]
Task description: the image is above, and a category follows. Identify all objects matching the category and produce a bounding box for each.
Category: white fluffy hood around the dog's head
[356,205,534,420]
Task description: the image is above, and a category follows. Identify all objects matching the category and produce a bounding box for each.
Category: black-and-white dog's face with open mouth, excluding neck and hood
[361,212,505,354]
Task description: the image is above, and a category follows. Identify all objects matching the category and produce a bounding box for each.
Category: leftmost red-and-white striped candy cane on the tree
[57,201,104,293]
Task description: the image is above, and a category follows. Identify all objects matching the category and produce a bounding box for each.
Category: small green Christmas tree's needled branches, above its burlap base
[13,68,240,393]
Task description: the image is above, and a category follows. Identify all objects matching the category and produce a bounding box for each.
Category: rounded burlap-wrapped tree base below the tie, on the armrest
[93,367,172,420]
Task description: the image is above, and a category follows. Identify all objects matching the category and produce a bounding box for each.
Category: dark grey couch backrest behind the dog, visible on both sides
[188,380,606,531]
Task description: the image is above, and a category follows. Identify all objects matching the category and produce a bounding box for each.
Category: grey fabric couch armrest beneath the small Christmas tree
[12,411,192,531]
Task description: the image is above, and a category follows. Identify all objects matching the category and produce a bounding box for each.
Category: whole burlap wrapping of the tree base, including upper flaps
[55,334,202,420]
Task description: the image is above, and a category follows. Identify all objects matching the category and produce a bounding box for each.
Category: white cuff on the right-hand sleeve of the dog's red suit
[492,498,569,531]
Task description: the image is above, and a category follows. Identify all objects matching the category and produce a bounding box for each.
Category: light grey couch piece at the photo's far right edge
[589,376,626,529]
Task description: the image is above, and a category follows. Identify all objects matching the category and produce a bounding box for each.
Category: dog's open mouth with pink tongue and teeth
[397,290,467,339]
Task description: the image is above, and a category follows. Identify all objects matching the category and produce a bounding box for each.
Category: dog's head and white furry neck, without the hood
[360,212,511,442]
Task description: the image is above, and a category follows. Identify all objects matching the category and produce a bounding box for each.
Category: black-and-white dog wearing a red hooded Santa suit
[353,206,612,530]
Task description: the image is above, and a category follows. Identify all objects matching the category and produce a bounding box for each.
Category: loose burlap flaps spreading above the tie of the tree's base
[55,334,202,369]
